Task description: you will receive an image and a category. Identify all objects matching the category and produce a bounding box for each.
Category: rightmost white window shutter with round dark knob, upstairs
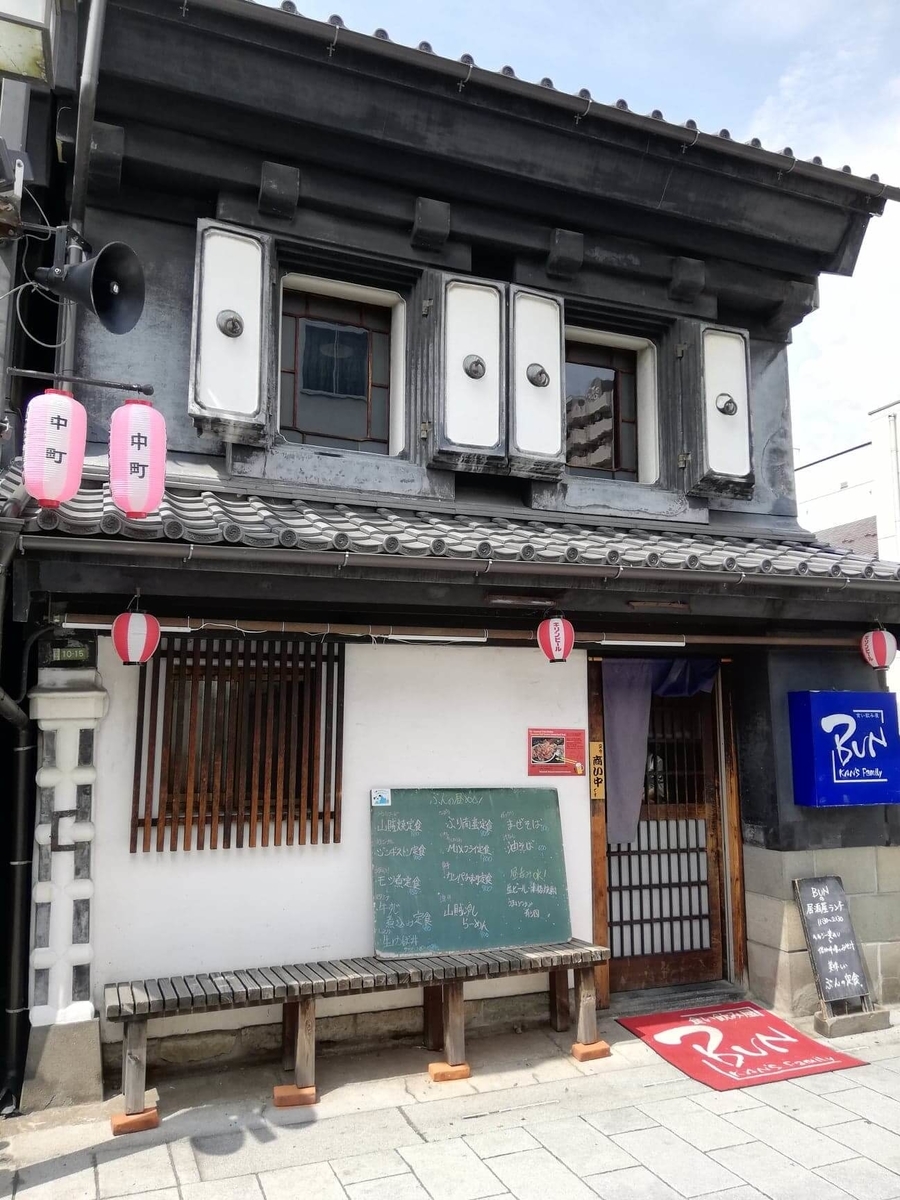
[698,326,754,494]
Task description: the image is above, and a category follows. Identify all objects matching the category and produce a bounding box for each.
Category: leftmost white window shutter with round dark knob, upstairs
[188,221,275,444]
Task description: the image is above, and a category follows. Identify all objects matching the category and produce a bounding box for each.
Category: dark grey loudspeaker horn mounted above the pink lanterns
[35,241,144,334]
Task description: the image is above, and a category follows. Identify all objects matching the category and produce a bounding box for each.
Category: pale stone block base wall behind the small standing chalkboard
[744,846,900,1015]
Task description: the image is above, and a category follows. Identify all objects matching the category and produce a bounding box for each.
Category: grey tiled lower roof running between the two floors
[0,462,900,582]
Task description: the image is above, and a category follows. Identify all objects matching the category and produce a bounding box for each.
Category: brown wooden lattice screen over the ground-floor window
[131,636,344,853]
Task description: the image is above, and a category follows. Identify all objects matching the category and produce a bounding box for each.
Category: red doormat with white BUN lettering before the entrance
[617,1003,865,1092]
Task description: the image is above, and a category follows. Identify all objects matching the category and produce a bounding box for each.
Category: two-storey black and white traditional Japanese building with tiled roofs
[0,0,900,1096]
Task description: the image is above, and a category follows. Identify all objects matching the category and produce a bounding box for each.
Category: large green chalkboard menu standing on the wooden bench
[372,787,571,958]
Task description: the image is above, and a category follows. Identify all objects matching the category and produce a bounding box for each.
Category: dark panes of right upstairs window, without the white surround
[565,342,637,480]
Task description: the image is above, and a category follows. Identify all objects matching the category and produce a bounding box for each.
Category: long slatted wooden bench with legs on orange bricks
[103,938,610,1133]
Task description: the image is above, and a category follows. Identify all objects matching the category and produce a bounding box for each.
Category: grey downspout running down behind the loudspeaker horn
[58,0,107,374]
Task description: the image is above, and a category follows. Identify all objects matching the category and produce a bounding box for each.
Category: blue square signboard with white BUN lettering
[787,691,900,808]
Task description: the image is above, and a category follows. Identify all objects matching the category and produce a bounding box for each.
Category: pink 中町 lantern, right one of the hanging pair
[109,397,166,517]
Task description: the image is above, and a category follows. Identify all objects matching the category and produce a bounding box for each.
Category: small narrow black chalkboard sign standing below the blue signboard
[793,875,874,1016]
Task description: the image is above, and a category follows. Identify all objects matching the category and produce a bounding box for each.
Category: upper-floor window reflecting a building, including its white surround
[565,325,659,484]
